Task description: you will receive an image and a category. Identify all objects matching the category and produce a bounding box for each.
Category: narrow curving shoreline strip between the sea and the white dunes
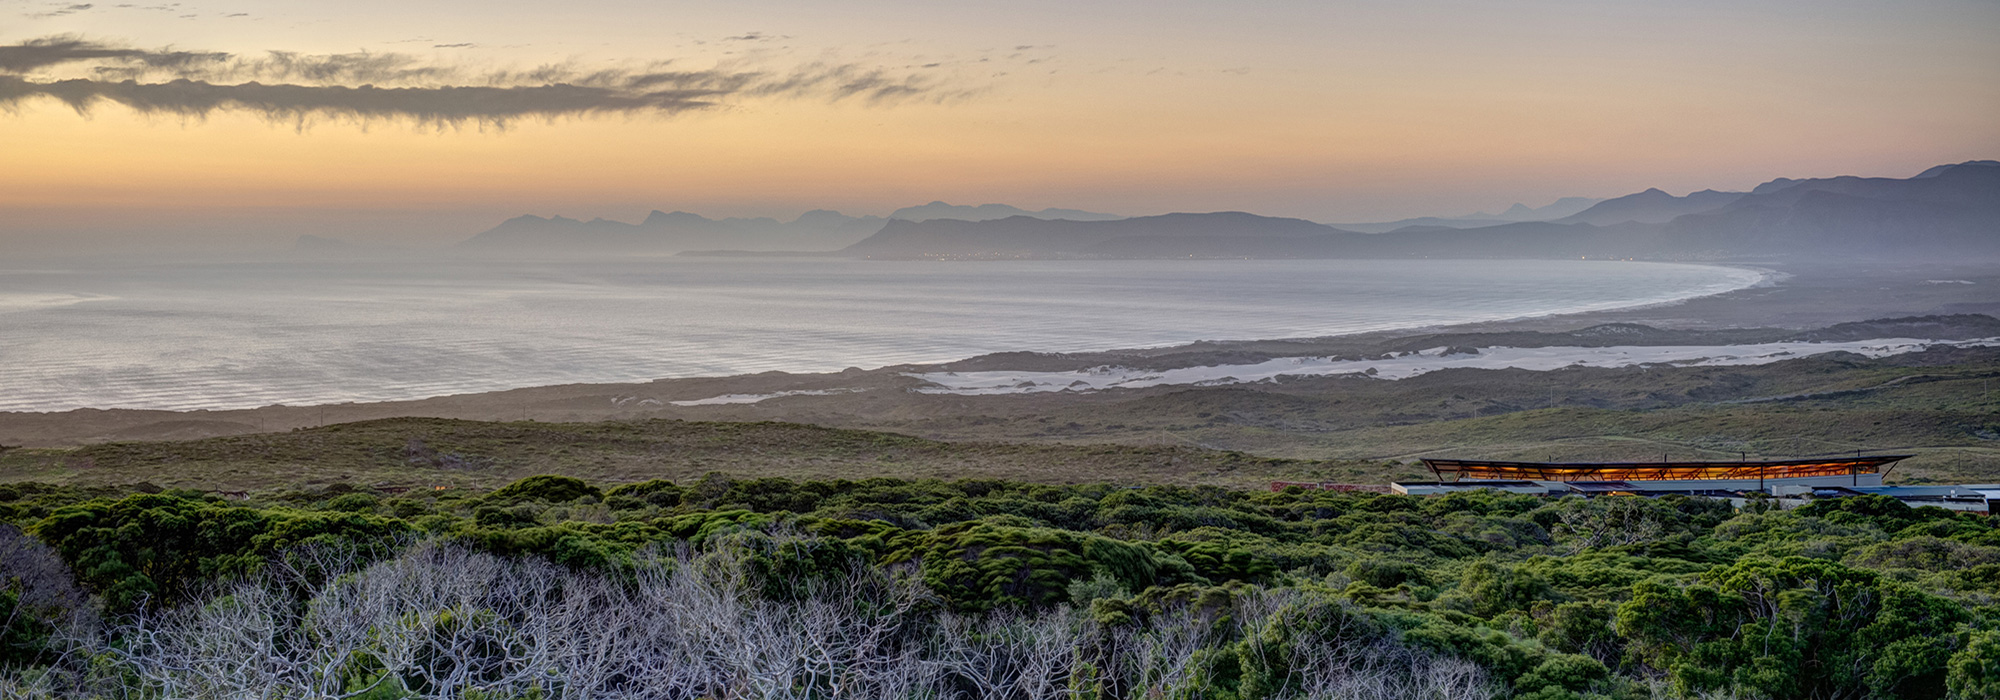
[0,264,2000,446]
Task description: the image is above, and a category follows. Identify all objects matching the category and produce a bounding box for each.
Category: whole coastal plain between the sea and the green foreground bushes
[0,264,2000,490]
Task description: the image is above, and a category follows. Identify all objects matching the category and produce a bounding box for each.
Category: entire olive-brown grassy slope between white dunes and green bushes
[0,350,2000,490]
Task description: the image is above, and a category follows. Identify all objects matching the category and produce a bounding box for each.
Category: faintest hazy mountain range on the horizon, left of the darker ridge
[458,202,1120,256]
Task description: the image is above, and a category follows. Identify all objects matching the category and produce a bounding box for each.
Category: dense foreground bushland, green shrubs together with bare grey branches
[0,474,2000,700]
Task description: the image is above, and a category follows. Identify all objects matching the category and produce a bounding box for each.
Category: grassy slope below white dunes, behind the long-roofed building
[860,350,2000,482]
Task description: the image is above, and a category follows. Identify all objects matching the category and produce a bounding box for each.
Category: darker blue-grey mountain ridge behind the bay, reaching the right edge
[840,160,2000,260]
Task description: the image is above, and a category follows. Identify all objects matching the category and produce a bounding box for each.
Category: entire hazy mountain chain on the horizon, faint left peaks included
[458,160,2000,260]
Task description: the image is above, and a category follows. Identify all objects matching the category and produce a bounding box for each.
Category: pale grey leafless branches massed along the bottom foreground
[0,534,1494,700]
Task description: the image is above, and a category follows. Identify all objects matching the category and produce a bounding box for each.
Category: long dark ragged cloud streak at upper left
[0,36,964,126]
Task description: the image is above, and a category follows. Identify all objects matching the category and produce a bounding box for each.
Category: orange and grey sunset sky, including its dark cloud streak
[0,0,2000,256]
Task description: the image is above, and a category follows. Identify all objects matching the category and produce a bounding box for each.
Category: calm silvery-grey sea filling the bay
[0,258,1758,410]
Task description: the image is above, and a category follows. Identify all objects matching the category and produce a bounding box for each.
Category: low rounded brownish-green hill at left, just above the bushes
[0,418,1414,490]
